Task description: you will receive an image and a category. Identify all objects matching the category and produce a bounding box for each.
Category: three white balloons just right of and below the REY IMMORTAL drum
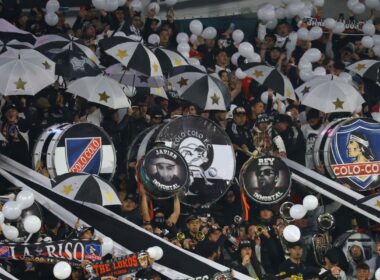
[283,195,318,242]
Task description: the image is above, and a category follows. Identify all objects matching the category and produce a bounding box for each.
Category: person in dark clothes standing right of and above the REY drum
[274,114,306,165]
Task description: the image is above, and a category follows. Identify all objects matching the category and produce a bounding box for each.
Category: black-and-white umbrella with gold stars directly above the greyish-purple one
[99,36,162,77]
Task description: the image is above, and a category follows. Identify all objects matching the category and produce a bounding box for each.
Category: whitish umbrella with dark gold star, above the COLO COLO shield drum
[67,75,131,109]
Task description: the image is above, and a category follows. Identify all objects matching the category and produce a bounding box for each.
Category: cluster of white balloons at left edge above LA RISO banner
[0,190,41,241]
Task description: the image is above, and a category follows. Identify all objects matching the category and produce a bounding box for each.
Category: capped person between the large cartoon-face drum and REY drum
[226,106,255,172]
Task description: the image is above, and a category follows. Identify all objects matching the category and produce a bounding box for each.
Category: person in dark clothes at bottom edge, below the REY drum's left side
[231,240,265,279]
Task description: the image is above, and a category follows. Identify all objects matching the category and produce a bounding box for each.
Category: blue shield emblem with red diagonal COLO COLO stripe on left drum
[65,137,102,174]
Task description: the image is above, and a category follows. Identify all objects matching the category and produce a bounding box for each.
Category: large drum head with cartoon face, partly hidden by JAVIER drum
[156,116,236,206]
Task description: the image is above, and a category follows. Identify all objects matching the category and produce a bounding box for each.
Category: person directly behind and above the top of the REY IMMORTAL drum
[252,114,286,157]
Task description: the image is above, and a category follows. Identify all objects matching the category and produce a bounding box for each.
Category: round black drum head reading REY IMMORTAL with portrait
[240,157,291,204]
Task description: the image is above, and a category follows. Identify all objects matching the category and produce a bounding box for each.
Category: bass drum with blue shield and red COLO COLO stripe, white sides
[33,123,116,180]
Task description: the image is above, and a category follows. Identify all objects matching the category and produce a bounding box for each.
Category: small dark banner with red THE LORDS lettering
[92,252,149,277]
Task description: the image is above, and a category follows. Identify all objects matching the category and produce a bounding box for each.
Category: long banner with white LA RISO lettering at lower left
[0,239,102,266]
